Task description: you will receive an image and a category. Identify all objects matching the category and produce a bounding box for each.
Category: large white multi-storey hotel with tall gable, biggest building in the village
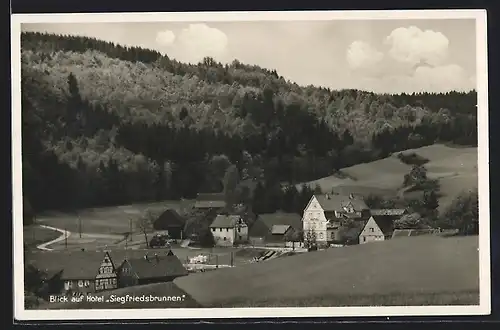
[302,194,370,246]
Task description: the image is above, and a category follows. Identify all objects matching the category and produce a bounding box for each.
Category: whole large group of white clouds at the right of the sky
[347,26,475,93]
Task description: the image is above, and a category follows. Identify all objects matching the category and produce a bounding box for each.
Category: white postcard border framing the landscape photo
[11,9,491,321]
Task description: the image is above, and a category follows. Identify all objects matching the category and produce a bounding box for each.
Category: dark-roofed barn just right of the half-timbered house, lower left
[118,251,188,287]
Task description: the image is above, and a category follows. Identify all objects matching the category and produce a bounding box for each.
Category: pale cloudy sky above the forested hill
[22,19,476,93]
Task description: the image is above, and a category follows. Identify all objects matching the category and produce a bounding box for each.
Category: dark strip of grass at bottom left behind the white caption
[37,282,201,309]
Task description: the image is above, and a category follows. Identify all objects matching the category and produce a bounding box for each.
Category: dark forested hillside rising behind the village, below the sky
[21,33,477,217]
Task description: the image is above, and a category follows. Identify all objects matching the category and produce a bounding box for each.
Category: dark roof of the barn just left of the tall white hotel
[249,212,302,237]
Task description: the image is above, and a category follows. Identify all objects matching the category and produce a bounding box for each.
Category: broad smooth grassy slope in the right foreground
[174,237,479,307]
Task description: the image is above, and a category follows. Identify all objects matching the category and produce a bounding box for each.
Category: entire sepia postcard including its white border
[12,10,490,320]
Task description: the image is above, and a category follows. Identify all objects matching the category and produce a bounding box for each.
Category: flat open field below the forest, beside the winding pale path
[37,201,192,235]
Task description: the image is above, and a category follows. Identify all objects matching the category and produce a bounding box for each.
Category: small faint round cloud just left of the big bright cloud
[346,41,384,71]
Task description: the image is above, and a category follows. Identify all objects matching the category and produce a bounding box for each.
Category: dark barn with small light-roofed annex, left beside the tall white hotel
[249,212,302,247]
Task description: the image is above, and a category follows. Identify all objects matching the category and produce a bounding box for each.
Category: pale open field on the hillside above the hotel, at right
[299,144,478,210]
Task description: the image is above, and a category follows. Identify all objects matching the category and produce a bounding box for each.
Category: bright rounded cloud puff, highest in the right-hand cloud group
[385,26,449,66]
